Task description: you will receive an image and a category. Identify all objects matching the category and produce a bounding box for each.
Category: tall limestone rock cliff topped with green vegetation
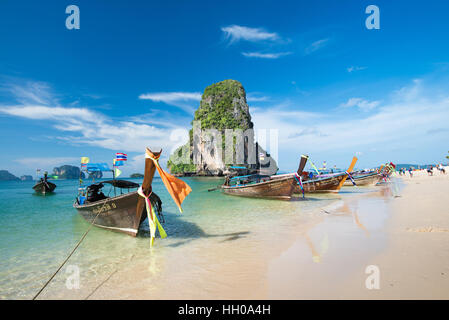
[167,80,278,176]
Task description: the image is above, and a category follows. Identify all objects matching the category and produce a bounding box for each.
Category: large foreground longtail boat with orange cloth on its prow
[73,148,191,243]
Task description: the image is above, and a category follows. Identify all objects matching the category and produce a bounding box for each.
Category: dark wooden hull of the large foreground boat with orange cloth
[73,191,146,237]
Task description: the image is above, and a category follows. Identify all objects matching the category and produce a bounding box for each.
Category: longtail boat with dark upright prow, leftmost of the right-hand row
[221,156,307,200]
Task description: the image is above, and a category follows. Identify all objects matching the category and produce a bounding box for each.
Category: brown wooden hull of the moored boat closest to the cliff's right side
[222,175,296,200]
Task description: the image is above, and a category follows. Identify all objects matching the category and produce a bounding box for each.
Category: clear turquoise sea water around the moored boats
[0,178,378,299]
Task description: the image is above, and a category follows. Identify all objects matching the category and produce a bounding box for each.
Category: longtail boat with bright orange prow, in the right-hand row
[295,157,357,193]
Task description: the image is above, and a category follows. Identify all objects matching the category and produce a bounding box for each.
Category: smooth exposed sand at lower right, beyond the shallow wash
[268,168,449,299]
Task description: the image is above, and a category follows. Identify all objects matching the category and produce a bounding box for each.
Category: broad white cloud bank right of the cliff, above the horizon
[251,81,449,160]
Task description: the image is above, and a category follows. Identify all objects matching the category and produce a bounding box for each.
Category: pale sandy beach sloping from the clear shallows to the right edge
[36,169,442,299]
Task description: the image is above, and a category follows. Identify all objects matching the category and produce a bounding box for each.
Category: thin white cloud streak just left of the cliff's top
[139,92,201,113]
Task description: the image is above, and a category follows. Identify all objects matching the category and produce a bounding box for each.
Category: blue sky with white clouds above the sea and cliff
[0,0,449,175]
